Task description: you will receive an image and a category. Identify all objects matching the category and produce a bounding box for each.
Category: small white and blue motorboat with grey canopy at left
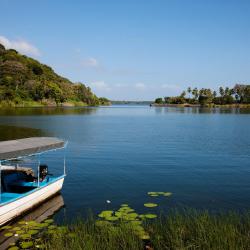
[0,137,67,225]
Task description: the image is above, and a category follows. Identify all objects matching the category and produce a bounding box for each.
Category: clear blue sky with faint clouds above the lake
[0,0,250,100]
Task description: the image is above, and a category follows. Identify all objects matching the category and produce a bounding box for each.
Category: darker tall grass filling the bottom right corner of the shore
[146,210,250,250]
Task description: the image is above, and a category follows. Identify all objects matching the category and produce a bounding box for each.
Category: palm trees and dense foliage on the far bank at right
[155,84,250,105]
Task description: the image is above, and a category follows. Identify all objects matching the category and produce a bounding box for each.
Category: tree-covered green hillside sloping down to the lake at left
[0,44,108,105]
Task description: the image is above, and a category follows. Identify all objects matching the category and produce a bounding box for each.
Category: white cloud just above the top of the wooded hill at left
[0,36,41,56]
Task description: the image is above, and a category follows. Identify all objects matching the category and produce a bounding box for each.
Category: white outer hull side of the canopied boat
[0,177,64,225]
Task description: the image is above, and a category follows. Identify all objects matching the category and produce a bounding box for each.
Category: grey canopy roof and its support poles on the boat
[0,137,68,202]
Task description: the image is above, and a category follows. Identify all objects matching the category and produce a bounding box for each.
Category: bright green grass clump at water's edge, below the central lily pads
[43,219,143,250]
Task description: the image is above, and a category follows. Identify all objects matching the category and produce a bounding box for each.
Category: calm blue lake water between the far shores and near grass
[0,106,250,223]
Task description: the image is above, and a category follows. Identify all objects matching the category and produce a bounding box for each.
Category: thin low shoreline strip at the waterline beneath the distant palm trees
[150,103,250,108]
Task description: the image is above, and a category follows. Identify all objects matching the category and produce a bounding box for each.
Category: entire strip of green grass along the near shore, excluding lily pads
[38,210,250,250]
